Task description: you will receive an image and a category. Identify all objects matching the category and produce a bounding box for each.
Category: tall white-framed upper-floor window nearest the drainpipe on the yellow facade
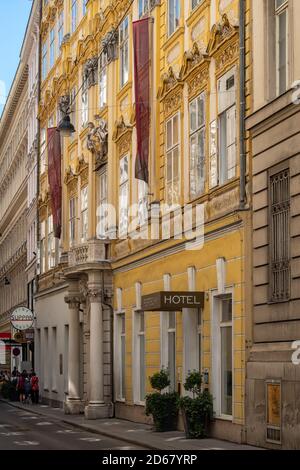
[218,68,237,184]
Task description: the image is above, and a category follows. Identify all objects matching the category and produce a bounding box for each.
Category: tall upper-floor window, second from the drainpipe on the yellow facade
[190,93,206,199]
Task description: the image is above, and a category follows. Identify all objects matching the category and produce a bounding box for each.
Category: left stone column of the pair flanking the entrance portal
[64,282,83,414]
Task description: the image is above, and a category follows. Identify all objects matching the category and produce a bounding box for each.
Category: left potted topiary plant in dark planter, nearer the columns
[146,369,178,432]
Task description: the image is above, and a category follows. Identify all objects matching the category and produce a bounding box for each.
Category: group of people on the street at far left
[0,367,39,404]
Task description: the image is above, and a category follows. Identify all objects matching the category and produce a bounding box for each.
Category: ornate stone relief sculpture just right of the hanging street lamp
[87,119,108,170]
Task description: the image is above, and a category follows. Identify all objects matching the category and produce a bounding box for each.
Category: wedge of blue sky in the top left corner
[0,0,32,116]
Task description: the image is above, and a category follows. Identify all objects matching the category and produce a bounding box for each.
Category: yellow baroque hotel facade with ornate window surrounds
[37,0,251,442]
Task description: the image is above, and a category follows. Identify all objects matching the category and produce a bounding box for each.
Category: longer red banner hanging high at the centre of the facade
[133,18,150,183]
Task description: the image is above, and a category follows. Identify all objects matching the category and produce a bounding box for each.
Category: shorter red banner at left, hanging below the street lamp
[47,127,62,238]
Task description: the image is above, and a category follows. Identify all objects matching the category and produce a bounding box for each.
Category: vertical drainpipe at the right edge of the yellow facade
[239,0,246,209]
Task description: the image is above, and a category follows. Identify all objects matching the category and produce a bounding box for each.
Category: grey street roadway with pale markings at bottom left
[0,402,142,450]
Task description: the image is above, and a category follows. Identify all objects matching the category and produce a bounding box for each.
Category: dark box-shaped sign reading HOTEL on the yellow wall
[142,291,204,312]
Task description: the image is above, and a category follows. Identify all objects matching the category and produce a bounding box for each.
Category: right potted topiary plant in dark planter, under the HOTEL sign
[179,370,213,439]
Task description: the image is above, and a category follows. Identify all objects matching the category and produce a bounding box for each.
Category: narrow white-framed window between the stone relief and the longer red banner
[119,155,129,235]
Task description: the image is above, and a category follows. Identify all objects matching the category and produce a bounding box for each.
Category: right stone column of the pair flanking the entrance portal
[84,271,110,419]
